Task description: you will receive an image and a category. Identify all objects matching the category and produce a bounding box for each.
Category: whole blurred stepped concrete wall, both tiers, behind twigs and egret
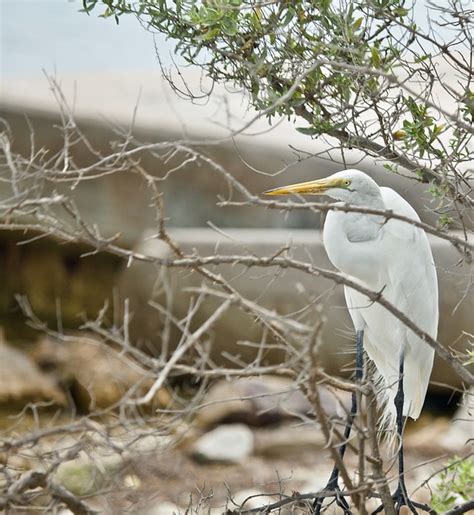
[0,90,474,394]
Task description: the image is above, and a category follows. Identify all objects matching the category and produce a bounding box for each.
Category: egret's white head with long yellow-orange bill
[263,170,380,204]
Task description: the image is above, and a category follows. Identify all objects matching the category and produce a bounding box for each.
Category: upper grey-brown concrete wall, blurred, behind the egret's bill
[0,102,452,246]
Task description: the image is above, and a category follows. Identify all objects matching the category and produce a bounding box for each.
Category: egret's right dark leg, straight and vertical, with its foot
[372,352,436,515]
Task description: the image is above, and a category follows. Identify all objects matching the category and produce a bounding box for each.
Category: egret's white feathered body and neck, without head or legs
[323,175,438,421]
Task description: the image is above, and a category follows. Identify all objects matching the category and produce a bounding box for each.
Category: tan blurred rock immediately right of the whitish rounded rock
[255,423,326,457]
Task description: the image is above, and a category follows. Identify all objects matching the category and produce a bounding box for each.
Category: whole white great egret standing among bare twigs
[265,170,438,514]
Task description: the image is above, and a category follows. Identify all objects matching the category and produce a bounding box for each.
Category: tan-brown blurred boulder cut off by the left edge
[0,333,66,406]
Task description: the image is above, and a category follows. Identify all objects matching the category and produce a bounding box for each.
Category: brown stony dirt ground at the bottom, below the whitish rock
[91,422,449,515]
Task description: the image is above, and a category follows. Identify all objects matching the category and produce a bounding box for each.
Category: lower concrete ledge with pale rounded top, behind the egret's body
[120,228,474,392]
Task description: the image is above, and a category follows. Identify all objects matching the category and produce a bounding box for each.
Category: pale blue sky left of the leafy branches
[0,0,172,77]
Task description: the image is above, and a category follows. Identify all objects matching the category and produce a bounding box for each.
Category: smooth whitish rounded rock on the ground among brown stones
[191,424,254,463]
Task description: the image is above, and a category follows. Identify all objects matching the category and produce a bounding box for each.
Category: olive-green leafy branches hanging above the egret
[83,0,474,222]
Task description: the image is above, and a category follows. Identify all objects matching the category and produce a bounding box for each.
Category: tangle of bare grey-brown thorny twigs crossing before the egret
[0,62,474,515]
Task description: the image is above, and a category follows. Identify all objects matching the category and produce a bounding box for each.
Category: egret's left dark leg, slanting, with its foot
[313,330,364,515]
